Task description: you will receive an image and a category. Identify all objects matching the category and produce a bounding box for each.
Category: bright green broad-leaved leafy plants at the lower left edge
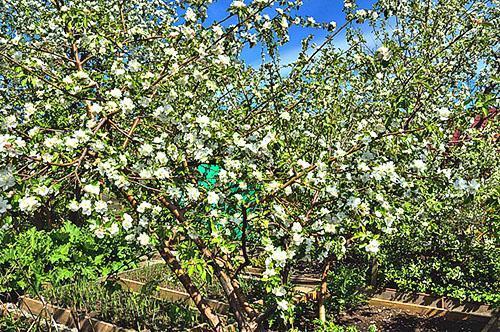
[0,222,145,293]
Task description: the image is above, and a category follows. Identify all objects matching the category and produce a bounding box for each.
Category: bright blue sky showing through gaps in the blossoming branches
[204,0,375,65]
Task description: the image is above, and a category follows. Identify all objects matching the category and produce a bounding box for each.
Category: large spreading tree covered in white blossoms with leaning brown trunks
[0,0,500,331]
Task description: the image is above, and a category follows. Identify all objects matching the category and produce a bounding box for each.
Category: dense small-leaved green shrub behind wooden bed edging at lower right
[380,218,500,306]
